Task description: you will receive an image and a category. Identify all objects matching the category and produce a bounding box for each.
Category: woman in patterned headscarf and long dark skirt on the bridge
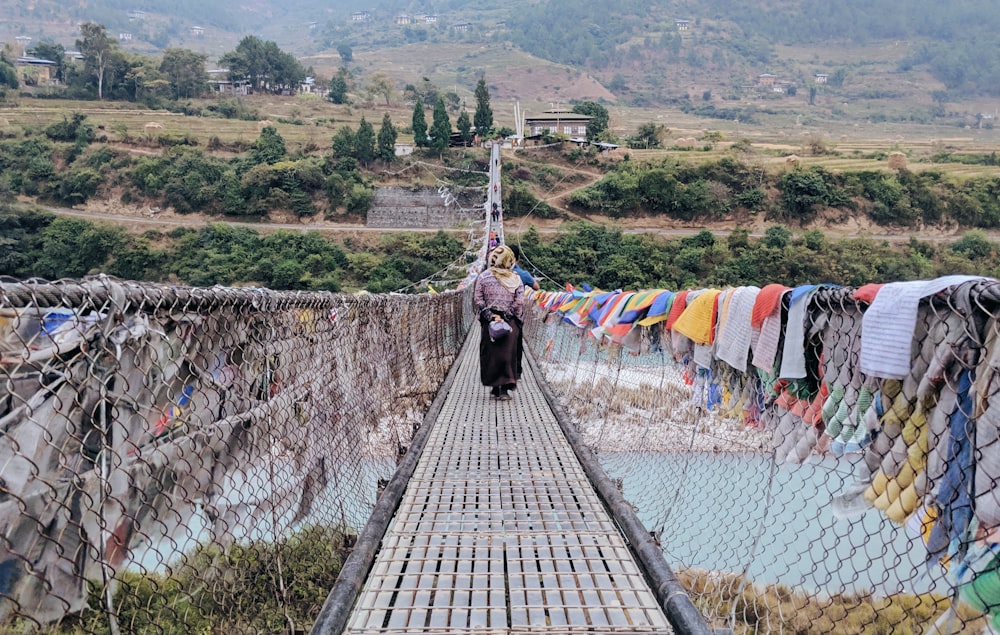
[475,245,524,401]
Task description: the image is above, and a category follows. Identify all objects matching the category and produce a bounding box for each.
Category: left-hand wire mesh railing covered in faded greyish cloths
[0,276,473,633]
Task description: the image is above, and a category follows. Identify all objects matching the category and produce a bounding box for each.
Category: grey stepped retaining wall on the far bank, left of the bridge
[367,187,486,229]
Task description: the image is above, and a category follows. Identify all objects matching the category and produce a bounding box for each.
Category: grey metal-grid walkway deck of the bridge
[347,327,670,634]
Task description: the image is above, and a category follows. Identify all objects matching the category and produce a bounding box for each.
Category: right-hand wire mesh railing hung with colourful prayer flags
[525,277,1000,633]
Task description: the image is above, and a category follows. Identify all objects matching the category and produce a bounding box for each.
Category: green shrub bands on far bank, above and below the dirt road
[0,107,1000,292]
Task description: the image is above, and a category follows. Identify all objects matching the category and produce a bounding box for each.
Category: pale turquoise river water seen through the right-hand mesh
[601,454,948,596]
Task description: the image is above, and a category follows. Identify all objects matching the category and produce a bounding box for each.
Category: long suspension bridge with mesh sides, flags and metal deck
[0,147,1000,635]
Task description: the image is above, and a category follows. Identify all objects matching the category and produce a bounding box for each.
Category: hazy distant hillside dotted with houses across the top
[0,0,1000,127]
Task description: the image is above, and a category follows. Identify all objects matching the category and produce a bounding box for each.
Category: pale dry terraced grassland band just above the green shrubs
[0,94,1000,184]
